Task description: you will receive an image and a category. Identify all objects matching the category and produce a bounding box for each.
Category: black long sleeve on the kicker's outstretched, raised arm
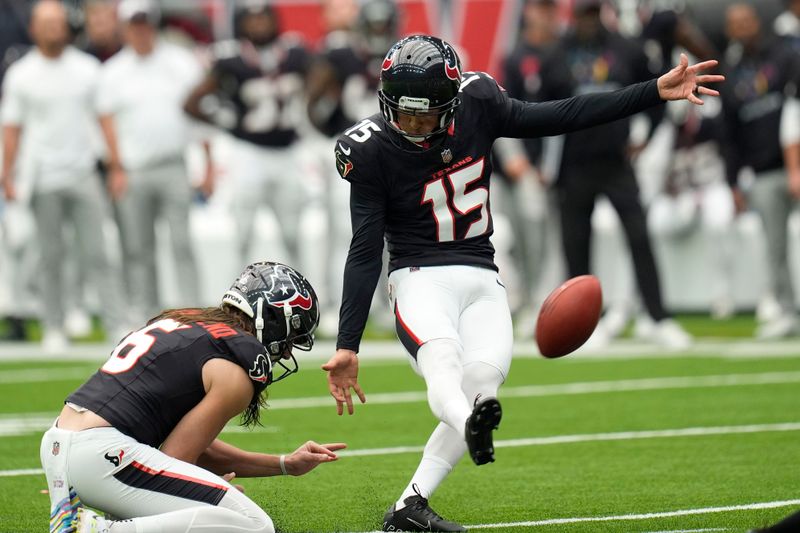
[496,80,663,138]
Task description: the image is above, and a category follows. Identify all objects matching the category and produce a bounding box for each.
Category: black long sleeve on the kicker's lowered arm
[336,142,386,352]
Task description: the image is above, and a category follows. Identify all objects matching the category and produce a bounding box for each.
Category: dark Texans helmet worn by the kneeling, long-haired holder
[222,261,319,383]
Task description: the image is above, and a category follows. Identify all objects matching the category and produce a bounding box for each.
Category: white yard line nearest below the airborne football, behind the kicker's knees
[0,372,800,438]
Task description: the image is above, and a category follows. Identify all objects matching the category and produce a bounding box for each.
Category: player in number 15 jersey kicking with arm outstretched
[323,35,724,531]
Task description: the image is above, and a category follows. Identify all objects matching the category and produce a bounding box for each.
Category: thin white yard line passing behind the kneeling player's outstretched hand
[6,422,800,478]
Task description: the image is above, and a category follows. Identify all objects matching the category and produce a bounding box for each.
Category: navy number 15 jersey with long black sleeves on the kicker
[335,72,661,350]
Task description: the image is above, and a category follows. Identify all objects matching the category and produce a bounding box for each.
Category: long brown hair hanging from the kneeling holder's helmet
[147,304,268,427]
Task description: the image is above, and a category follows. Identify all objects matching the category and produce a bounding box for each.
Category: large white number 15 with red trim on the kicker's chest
[422,158,489,242]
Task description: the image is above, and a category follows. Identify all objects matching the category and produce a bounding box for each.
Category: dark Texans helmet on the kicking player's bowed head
[378,35,461,142]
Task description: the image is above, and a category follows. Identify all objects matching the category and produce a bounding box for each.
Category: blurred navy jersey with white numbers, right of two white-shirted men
[212,38,308,147]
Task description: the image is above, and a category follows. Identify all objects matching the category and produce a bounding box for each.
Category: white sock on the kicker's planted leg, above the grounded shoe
[395,422,467,510]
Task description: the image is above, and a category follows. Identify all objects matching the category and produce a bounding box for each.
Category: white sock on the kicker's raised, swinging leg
[417,339,472,439]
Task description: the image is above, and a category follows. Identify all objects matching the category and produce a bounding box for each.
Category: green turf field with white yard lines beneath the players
[0,330,800,533]
